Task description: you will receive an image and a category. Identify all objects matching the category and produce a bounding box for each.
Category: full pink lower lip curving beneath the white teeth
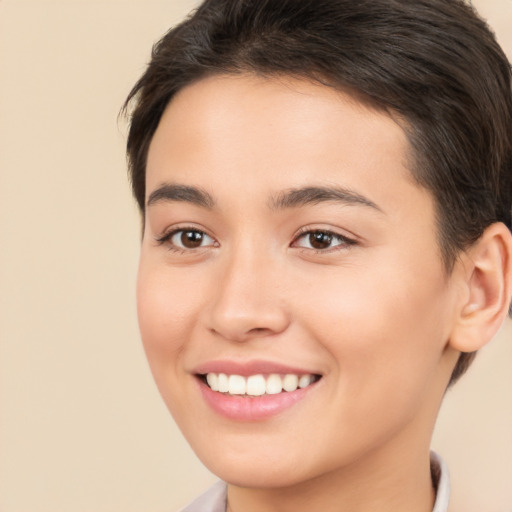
[199,381,316,421]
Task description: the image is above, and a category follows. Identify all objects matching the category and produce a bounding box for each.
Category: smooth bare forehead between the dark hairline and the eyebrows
[146,75,417,214]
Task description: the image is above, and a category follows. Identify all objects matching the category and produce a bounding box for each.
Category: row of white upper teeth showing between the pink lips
[206,373,315,396]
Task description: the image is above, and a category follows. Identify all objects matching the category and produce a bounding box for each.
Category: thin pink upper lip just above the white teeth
[192,360,319,377]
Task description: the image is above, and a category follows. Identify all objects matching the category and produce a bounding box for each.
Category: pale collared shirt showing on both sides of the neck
[179,452,450,512]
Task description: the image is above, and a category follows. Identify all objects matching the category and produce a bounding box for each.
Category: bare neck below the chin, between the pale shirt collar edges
[227,450,435,512]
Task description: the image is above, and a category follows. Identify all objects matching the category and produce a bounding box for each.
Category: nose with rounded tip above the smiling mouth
[207,246,289,342]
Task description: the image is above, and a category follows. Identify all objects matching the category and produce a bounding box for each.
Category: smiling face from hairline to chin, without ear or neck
[138,76,456,487]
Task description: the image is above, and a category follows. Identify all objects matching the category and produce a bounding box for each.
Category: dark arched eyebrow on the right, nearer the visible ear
[270,186,383,213]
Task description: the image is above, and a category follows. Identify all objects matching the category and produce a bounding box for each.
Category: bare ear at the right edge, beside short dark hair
[450,222,512,352]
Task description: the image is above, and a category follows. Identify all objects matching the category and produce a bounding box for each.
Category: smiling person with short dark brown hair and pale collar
[123,0,512,512]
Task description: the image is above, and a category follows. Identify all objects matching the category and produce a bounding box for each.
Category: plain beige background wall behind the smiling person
[0,0,512,512]
